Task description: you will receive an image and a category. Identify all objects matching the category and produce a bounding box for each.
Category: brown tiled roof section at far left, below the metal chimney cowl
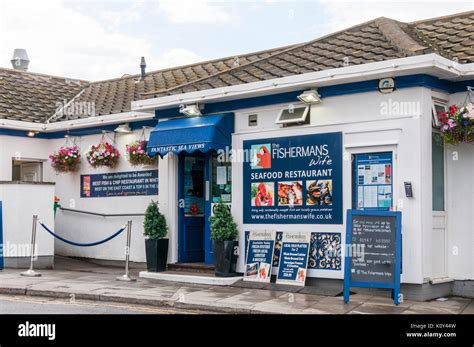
[0,68,88,123]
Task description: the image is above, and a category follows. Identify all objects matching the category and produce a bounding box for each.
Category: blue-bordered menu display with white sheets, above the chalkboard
[352,152,393,211]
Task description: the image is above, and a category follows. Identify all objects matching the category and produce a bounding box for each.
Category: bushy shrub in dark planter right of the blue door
[210,202,238,277]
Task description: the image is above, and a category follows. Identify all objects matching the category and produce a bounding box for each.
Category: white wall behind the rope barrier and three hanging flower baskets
[48,130,159,262]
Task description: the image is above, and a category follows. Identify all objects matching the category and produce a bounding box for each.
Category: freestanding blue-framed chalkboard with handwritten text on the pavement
[344,210,402,305]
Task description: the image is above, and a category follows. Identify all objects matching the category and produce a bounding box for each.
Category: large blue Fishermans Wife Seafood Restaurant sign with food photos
[243,132,342,224]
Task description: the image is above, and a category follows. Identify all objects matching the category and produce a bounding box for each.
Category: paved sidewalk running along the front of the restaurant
[0,258,474,314]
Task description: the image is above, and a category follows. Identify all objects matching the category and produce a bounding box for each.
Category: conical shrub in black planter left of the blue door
[143,201,168,272]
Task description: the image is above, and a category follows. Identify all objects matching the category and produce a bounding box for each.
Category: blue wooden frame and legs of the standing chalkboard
[344,210,402,305]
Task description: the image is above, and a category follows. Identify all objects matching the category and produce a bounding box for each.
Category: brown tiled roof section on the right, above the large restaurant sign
[155,11,474,96]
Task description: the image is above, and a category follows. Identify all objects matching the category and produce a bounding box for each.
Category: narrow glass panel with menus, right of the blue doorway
[212,155,232,203]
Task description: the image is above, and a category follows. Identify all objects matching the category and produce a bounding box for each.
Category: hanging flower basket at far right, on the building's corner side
[439,103,474,145]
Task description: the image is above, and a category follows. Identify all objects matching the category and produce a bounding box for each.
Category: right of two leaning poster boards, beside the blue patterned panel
[276,231,311,286]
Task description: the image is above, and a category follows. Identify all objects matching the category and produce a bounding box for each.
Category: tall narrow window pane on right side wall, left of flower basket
[431,133,444,211]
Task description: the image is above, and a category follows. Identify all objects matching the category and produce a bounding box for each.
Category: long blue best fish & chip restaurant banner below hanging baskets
[81,170,158,198]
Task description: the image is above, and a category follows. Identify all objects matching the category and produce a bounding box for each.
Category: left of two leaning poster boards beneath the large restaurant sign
[244,230,275,283]
